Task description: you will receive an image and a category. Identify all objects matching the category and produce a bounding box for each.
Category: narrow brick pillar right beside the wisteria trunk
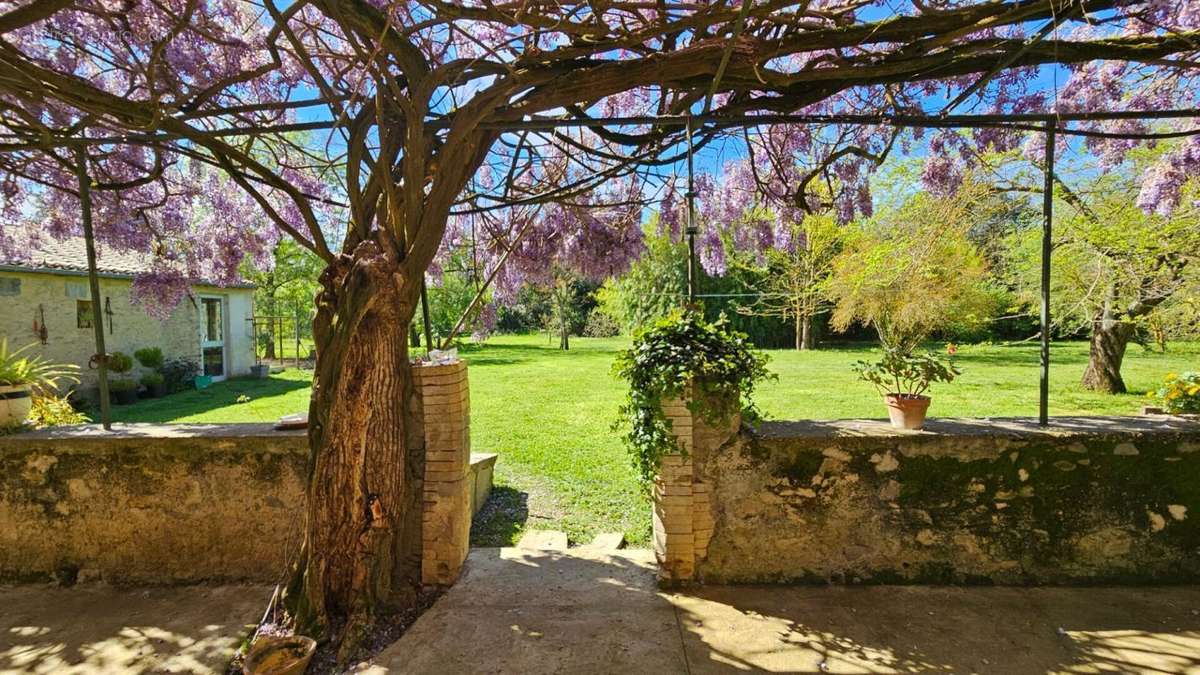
[413,362,470,586]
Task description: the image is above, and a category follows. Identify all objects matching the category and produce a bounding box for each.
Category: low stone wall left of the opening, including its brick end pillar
[0,363,496,585]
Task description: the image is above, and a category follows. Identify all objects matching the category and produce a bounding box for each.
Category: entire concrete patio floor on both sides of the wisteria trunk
[0,549,1200,674]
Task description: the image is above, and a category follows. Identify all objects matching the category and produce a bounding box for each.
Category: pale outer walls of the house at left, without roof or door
[0,270,254,390]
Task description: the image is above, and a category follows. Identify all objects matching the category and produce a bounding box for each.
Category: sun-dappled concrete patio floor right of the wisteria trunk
[366,549,1200,674]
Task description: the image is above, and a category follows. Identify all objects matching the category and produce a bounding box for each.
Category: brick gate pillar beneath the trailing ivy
[654,391,742,583]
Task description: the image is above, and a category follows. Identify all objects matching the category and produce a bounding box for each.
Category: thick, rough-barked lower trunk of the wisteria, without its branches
[284,241,425,662]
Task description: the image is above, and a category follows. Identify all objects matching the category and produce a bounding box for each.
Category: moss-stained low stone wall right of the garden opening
[655,417,1200,584]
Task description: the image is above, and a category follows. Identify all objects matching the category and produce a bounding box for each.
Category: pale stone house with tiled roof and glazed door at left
[0,238,254,395]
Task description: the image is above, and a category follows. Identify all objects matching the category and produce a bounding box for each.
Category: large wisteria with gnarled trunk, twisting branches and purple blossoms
[0,0,1200,655]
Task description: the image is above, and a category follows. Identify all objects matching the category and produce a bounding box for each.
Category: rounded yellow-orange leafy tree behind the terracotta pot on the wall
[827,184,992,354]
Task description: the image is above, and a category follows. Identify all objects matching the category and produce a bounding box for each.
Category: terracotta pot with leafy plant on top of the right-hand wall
[853,350,961,429]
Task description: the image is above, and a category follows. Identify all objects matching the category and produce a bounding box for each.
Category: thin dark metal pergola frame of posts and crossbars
[51,107,1200,429]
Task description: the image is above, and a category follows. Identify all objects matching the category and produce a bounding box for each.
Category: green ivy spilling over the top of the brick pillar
[613,311,770,482]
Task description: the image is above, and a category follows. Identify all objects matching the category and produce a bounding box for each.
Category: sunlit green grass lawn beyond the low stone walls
[105,335,1200,545]
